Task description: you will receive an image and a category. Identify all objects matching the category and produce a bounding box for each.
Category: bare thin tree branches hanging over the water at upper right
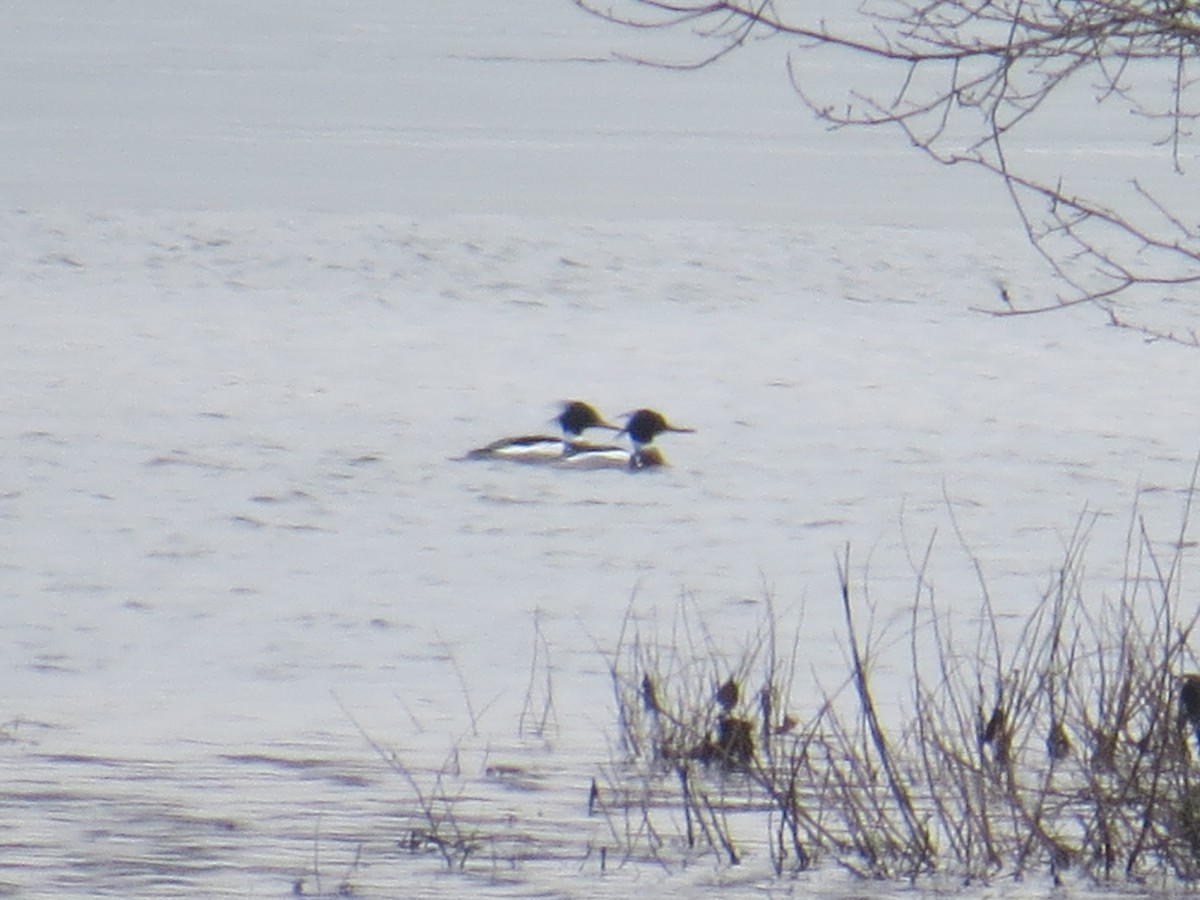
[572,0,1200,343]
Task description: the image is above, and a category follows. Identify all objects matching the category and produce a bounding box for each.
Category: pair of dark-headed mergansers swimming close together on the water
[467,400,694,472]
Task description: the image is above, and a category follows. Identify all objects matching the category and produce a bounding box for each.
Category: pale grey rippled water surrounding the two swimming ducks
[0,0,1200,896]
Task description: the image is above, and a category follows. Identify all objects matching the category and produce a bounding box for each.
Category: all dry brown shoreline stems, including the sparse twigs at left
[372,480,1200,892]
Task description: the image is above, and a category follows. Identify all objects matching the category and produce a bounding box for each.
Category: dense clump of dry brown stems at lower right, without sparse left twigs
[594,496,1200,882]
